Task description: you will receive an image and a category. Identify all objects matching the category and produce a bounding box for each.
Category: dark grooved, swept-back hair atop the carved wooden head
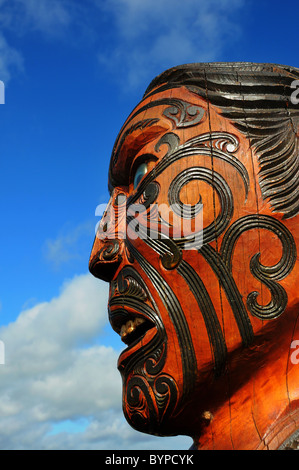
[109,63,299,218]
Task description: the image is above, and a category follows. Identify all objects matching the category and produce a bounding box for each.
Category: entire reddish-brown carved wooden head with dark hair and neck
[90,63,299,449]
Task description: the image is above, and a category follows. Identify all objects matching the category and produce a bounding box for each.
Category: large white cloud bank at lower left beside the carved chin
[0,274,191,450]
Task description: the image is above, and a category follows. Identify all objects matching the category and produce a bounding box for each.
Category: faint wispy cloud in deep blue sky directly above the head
[98,0,244,86]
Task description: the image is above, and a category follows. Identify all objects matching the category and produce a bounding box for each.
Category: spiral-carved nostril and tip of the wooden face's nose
[89,238,123,282]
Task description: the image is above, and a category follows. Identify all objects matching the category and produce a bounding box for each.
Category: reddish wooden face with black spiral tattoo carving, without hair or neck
[90,87,298,435]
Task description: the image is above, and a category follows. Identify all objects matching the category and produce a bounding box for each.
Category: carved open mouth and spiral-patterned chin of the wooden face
[109,267,178,434]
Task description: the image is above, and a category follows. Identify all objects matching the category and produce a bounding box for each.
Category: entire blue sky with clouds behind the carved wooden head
[0,0,299,449]
